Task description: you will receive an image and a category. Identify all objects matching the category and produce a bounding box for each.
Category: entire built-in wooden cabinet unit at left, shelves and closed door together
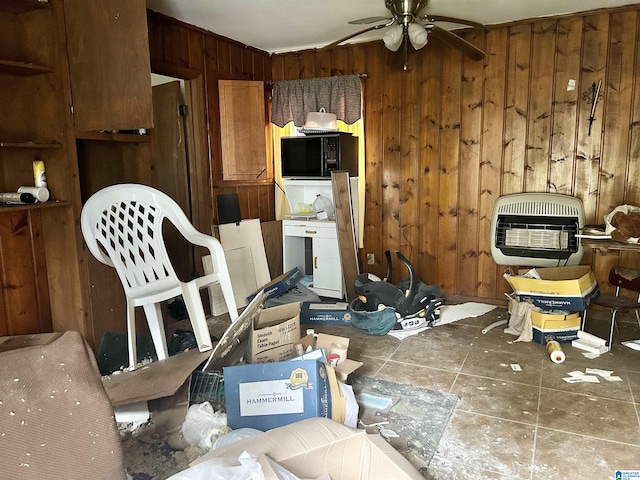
[0,0,154,348]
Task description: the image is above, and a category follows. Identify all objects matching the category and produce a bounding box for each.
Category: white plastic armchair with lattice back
[81,184,238,369]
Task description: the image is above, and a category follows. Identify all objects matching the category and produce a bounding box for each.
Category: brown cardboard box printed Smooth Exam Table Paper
[249,303,300,363]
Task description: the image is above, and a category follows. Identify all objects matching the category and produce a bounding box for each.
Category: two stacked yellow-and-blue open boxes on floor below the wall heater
[505,265,600,344]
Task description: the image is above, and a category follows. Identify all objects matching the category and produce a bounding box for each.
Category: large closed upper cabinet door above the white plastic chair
[64,0,153,132]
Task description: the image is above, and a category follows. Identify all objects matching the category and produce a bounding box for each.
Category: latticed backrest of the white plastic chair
[81,184,195,294]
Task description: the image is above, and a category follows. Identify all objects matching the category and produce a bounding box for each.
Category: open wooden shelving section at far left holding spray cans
[0,0,85,335]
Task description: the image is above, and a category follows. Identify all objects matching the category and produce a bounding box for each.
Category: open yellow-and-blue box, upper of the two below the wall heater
[504,265,600,312]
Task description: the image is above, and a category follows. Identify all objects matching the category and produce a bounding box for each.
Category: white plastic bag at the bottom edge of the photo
[167,450,264,480]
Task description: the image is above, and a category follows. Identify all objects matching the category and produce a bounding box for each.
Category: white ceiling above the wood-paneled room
[146,0,638,53]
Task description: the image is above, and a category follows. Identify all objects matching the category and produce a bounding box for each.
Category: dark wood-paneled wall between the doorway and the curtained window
[147,11,275,232]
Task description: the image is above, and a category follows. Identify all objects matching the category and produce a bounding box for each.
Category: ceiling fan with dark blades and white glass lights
[323,0,486,70]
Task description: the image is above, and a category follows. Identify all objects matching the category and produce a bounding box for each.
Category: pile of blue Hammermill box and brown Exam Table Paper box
[215,293,362,430]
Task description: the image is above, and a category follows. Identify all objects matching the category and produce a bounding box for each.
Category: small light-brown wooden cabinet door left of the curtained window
[218,80,271,181]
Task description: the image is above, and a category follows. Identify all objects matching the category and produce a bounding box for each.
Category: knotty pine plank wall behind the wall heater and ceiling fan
[272,5,640,299]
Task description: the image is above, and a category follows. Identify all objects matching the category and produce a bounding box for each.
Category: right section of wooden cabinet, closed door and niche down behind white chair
[64,0,157,348]
